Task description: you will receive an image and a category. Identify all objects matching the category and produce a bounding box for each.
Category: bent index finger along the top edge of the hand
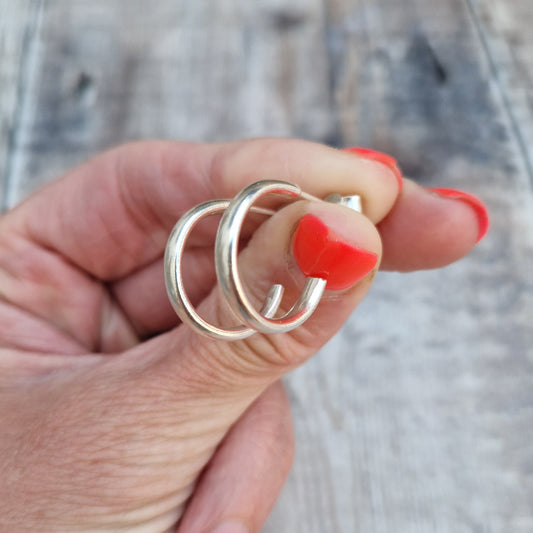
[5,139,398,281]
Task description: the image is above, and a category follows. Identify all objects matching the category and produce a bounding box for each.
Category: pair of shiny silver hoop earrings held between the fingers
[165,180,362,341]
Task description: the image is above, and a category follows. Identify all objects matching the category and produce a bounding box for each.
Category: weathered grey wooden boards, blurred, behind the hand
[0,0,533,533]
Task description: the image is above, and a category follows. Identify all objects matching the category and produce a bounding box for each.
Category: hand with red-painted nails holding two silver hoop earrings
[0,140,479,533]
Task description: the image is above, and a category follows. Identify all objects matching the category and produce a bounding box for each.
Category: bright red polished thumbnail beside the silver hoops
[293,215,378,290]
